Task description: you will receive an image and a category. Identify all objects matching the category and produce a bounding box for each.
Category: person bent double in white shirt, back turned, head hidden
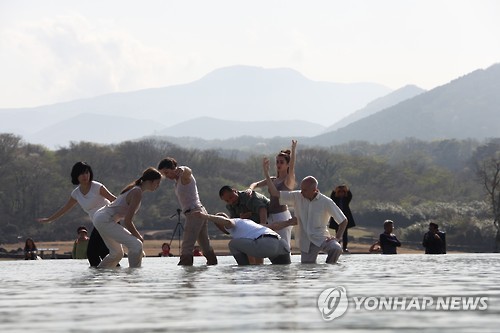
[198,212,297,265]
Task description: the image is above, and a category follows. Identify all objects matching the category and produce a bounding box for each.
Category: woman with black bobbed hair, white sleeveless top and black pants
[38,162,116,267]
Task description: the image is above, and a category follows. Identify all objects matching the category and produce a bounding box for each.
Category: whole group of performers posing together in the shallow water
[38,140,360,268]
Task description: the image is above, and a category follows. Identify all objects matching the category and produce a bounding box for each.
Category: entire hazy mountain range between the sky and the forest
[0,64,500,148]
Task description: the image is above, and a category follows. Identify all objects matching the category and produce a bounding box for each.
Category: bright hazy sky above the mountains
[0,0,500,108]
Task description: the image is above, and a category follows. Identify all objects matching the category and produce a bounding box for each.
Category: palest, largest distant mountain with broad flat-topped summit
[0,66,391,145]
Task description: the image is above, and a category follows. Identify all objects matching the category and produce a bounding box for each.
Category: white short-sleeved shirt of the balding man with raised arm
[280,190,346,252]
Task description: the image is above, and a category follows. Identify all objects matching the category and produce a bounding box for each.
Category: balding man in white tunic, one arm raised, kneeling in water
[263,158,347,264]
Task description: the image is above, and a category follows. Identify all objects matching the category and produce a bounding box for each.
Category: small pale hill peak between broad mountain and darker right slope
[325,85,425,132]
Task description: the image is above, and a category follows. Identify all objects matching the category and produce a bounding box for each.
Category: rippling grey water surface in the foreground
[0,254,500,333]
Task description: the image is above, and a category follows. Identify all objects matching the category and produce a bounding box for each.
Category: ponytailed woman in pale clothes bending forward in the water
[93,168,161,268]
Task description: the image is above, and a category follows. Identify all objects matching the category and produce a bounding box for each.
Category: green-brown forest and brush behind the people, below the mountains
[0,134,500,252]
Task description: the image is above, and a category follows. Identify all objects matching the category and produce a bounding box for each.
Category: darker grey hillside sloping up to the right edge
[304,64,500,146]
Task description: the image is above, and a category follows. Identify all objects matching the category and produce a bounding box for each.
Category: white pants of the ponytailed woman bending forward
[93,212,143,268]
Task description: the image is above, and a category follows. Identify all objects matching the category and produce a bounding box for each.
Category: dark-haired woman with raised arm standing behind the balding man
[249,140,297,248]
